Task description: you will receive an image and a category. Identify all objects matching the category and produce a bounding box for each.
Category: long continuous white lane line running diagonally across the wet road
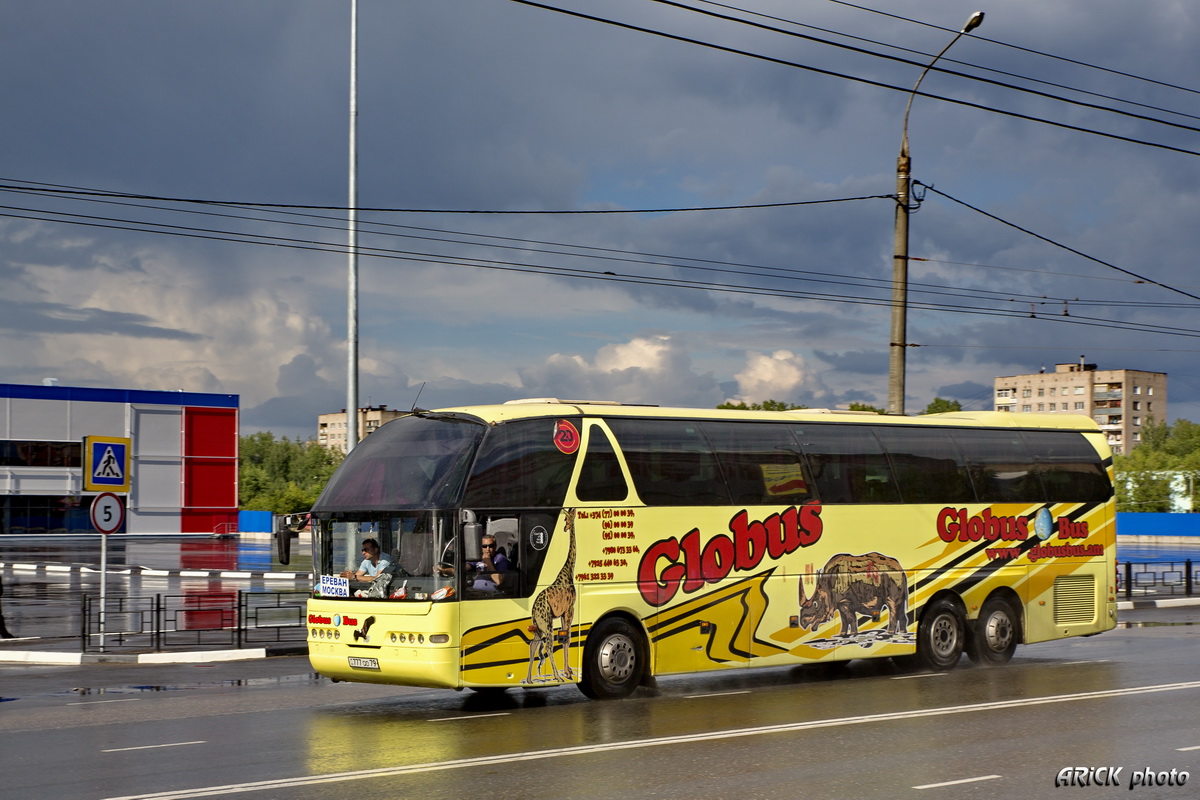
[107,680,1200,800]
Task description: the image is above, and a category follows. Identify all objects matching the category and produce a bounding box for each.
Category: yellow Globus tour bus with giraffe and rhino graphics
[297,398,1116,699]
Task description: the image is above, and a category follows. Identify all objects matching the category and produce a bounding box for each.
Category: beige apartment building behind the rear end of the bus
[995,359,1166,453]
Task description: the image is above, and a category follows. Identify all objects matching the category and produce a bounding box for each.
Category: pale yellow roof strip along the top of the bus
[417,397,1099,432]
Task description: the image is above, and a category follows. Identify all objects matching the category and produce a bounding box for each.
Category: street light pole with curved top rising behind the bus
[888,11,983,416]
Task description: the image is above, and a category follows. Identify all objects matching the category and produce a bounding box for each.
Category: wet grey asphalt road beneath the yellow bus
[0,607,1200,800]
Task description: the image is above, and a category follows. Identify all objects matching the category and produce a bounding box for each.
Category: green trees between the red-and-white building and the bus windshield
[238,431,342,513]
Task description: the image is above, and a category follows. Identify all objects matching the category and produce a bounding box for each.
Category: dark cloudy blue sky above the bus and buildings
[0,0,1200,437]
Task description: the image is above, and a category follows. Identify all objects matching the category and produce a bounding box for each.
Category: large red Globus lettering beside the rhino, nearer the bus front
[637,500,822,607]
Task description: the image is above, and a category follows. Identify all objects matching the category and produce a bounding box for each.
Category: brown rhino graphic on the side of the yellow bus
[800,553,908,637]
